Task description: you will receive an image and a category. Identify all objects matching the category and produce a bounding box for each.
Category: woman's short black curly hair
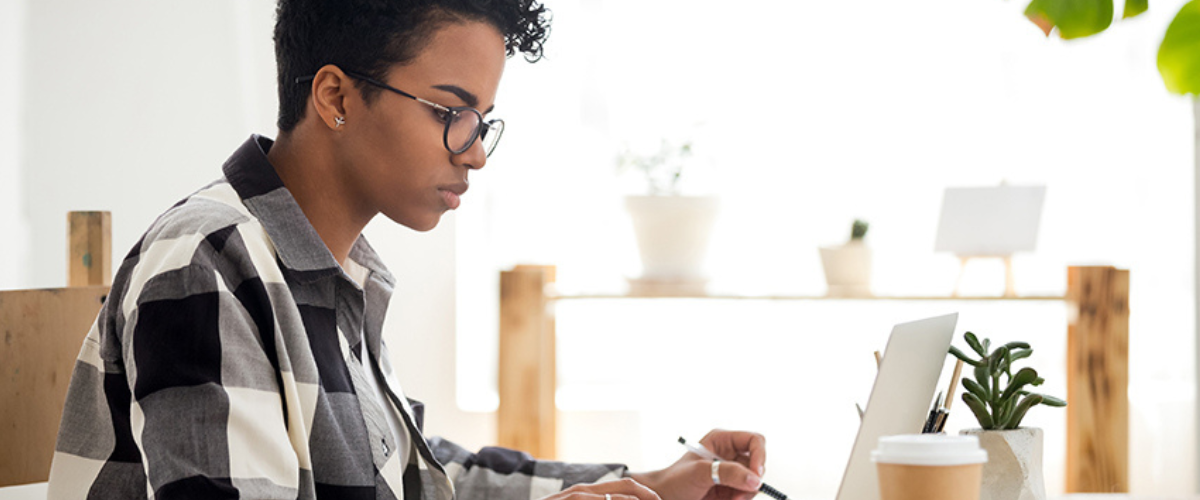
[275,0,551,132]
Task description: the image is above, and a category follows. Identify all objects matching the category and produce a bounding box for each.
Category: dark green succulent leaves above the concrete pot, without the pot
[950,332,1067,430]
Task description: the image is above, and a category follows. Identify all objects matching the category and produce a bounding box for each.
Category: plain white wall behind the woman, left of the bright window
[0,0,484,446]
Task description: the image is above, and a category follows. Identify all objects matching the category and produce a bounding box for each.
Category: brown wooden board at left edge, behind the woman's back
[0,287,108,487]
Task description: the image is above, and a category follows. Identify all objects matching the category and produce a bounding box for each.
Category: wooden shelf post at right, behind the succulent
[1067,267,1129,493]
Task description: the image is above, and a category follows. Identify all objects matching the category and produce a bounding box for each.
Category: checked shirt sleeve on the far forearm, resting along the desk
[428,431,626,500]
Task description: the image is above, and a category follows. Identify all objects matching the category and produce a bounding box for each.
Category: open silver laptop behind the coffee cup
[838,313,959,500]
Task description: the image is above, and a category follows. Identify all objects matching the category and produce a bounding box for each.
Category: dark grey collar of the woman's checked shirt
[222,134,395,285]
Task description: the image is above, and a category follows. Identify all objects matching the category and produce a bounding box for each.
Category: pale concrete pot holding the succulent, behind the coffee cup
[960,427,1046,500]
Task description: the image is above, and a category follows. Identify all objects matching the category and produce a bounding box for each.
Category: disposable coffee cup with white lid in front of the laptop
[871,434,988,500]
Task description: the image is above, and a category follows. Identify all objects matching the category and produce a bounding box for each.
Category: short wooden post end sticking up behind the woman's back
[67,212,113,287]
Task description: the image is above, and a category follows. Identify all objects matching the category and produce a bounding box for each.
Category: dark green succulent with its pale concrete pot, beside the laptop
[950,332,1067,500]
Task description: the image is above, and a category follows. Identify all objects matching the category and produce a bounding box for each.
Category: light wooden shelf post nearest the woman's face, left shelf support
[497,266,558,459]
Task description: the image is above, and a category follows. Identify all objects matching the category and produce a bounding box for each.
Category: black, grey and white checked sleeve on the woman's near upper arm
[122,264,299,499]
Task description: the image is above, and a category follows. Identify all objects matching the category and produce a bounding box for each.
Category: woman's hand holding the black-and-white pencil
[634,430,767,500]
